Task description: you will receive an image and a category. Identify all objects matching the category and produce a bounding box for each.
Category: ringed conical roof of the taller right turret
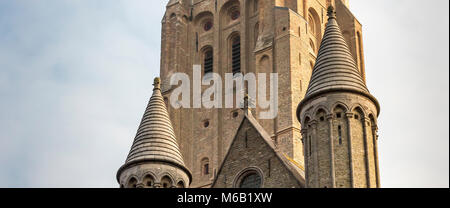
[305,6,369,99]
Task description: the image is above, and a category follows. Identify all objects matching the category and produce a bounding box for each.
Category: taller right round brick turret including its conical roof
[297,6,380,188]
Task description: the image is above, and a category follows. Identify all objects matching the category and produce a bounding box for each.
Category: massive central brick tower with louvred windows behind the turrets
[160,0,365,188]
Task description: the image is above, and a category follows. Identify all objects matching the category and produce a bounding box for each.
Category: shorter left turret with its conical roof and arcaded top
[117,78,192,188]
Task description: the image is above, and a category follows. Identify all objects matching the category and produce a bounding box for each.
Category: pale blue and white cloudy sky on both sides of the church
[0,0,449,187]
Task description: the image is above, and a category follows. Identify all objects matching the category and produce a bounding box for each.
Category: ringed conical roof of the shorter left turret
[119,78,191,181]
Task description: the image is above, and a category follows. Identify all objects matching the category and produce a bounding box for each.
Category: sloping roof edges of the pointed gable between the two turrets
[212,112,305,187]
